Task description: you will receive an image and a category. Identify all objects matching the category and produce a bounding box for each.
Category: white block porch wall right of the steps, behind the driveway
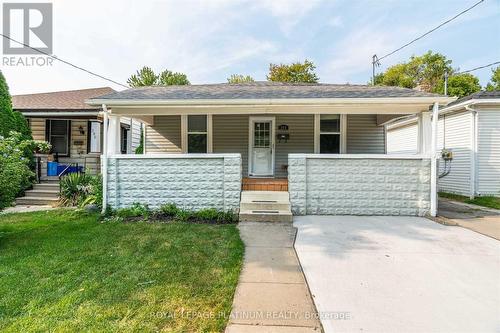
[288,154,431,216]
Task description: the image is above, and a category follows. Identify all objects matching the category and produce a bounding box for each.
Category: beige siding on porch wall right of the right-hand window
[346,114,385,154]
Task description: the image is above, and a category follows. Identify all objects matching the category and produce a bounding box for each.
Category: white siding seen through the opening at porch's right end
[387,123,418,154]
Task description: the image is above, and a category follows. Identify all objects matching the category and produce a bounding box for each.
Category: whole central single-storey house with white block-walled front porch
[87,82,454,220]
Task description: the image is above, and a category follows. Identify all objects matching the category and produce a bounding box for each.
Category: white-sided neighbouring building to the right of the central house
[386,91,500,198]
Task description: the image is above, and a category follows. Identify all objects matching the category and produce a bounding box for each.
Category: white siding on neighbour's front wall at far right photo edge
[476,110,500,196]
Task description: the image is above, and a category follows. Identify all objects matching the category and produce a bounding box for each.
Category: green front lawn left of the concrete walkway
[0,210,244,332]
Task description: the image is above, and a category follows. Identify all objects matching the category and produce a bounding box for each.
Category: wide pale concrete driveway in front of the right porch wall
[294,216,500,332]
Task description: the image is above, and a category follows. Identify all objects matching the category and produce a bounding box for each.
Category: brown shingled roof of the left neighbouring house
[12,87,115,111]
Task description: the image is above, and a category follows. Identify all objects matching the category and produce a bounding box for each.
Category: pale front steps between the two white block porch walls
[240,191,293,223]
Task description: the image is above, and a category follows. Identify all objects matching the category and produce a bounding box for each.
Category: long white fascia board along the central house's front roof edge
[85,96,456,107]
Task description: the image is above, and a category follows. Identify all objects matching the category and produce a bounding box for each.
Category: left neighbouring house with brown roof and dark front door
[12,87,142,180]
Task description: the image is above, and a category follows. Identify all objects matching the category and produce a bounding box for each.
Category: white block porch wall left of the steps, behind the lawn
[107,154,241,211]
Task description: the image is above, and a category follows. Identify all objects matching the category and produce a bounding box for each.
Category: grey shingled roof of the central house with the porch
[90,81,439,100]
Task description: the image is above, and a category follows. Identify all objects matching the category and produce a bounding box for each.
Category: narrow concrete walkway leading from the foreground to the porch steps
[226,222,321,333]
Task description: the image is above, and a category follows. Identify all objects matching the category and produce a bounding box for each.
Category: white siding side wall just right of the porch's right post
[438,111,472,196]
